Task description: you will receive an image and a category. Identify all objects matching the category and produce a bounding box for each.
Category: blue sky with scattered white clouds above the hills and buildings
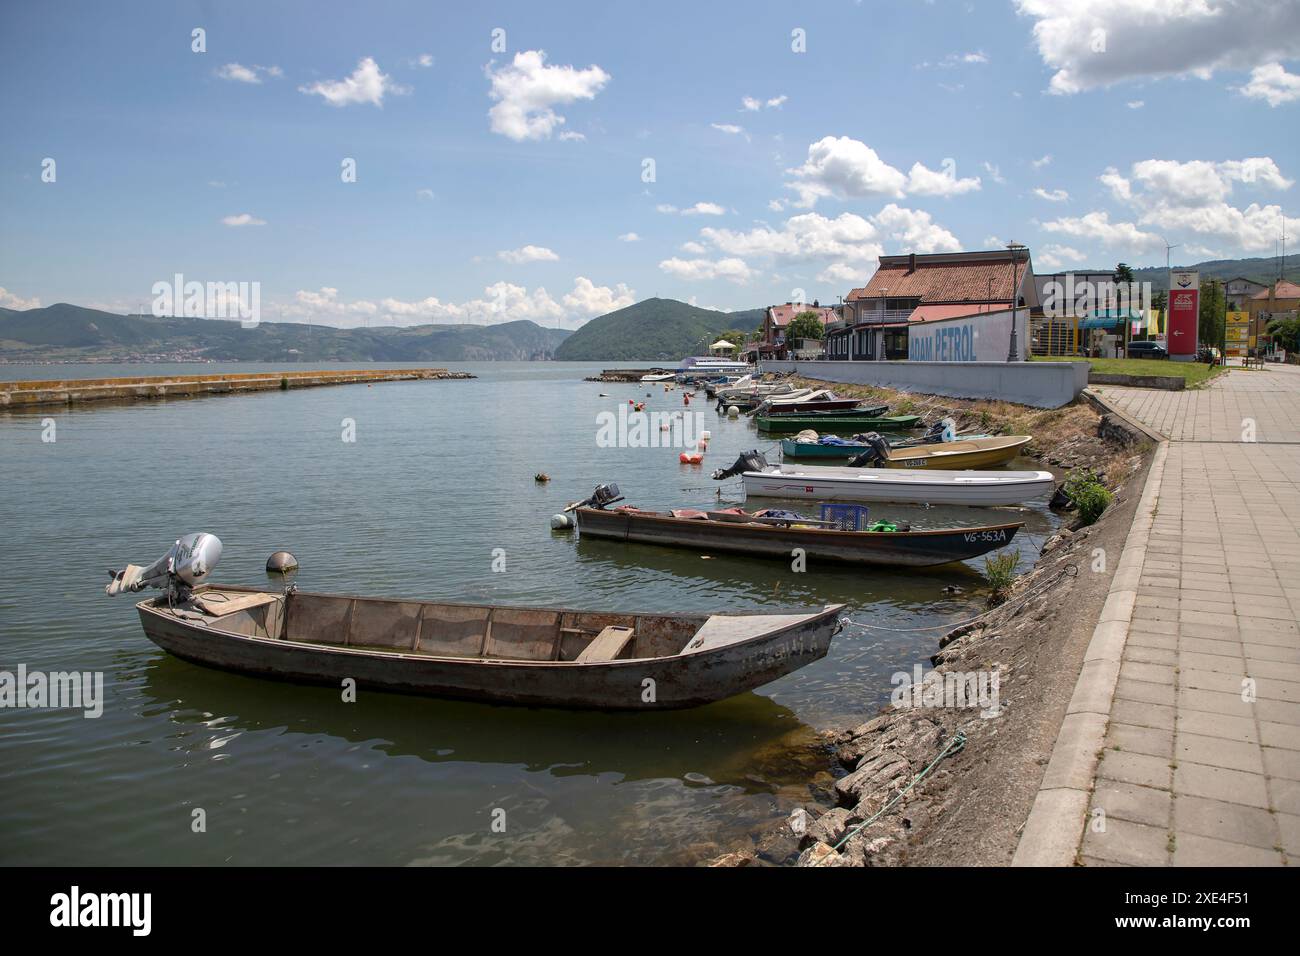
[0,0,1300,328]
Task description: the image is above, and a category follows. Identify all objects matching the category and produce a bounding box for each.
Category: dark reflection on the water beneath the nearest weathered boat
[139,654,824,793]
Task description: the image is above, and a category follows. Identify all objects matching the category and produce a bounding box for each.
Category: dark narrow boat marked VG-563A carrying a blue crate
[575,507,1024,567]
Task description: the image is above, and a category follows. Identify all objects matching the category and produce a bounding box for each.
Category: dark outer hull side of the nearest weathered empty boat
[137,588,842,711]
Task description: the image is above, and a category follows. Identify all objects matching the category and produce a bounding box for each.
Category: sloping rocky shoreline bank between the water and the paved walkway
[707,385,1154,866]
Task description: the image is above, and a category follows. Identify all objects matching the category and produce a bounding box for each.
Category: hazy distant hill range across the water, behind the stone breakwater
[0,303,569,362]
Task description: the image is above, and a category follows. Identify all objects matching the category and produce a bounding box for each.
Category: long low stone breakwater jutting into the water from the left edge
[0,368,475,408]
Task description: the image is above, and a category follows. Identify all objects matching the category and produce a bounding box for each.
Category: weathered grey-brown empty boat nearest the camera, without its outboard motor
[137,585,842,710]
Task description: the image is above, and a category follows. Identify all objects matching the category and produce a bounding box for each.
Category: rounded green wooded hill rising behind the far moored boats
[555,299,766,362]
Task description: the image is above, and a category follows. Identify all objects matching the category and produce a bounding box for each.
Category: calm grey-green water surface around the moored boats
[0,363,1056,865]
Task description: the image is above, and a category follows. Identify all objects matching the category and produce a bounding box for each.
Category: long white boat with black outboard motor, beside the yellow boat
[714,451,1056,506]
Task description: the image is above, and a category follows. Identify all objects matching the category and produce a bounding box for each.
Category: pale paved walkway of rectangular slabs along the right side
[1079,367,1300,866]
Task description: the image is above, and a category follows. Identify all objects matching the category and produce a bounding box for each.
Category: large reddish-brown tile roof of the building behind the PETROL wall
[848,255,1028,303]
